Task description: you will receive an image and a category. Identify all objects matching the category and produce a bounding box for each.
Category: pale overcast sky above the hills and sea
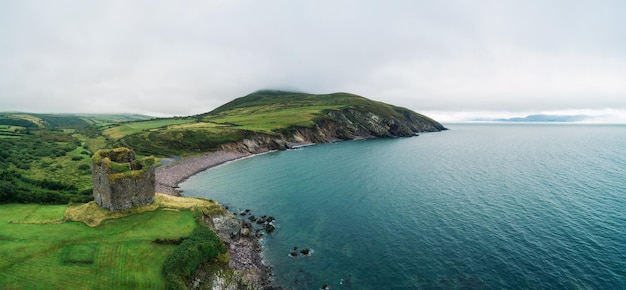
[0,0,626,122]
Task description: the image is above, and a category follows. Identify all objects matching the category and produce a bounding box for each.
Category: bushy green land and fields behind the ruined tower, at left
[0,113,151,204]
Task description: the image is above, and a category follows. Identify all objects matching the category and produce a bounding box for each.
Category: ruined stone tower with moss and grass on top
[91,148,155,211]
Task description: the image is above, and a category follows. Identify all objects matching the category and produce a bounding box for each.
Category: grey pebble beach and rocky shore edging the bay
[156,151,274,289]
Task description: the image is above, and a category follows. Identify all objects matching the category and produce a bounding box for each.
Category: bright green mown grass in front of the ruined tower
[0,204,196,289]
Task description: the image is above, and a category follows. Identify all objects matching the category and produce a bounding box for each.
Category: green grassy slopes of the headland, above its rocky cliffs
[116,90,438,155]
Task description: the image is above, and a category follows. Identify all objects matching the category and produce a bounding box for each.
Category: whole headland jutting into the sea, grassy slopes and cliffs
[120,90,445,155]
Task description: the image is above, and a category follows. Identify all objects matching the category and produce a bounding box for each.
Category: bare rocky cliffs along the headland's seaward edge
[220,109,446,153]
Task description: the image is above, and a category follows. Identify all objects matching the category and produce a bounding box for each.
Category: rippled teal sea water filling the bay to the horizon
[181,124,626,289]
